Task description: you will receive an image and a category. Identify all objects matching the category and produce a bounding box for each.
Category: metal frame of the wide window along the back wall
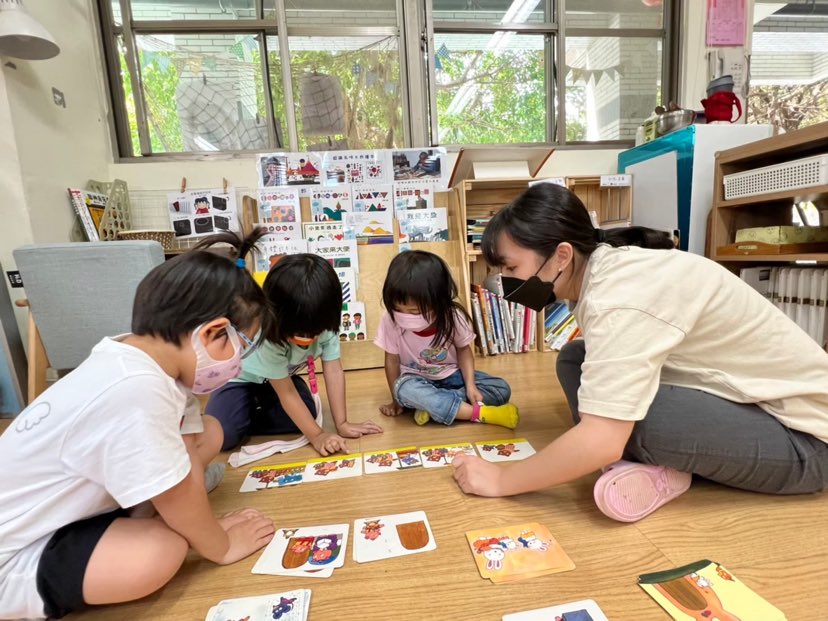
[98,0,683,162]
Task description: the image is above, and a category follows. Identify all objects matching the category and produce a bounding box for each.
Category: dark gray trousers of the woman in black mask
[557,339,828,494]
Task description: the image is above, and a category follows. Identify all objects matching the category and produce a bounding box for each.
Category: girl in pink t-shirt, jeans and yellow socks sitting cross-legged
[374,250,519,429]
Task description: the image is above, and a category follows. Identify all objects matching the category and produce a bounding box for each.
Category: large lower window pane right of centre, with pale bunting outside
[566,37,662,141]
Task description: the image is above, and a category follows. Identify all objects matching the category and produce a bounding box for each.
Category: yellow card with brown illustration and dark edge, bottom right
[638,559,785,621]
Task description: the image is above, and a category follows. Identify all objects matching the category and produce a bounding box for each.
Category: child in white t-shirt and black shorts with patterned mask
[0,233,273,619]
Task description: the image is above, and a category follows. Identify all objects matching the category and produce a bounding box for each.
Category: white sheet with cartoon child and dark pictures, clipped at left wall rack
[167,188,239,238]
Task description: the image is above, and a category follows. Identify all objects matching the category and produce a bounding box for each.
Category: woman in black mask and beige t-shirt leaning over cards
[453,183,828,522]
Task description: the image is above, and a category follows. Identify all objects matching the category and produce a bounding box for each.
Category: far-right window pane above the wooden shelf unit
[752,2,828,131]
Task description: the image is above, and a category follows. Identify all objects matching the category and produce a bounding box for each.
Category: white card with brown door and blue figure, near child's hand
[252,524,349,577]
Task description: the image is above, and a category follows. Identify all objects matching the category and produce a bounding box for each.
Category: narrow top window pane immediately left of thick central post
[285,0,397,27]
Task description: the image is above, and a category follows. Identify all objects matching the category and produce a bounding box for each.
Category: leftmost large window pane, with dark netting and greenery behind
[137,34,269,153]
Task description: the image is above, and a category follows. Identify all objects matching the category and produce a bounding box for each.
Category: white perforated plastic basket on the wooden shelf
[724,154,828,200]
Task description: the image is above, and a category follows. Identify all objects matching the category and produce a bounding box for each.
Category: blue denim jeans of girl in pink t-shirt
[394,369,512,425]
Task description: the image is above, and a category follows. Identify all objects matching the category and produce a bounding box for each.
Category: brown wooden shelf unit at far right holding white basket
[709,123,828,272]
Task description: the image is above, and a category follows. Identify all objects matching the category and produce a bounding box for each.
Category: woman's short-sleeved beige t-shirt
[575,245,828,442]
